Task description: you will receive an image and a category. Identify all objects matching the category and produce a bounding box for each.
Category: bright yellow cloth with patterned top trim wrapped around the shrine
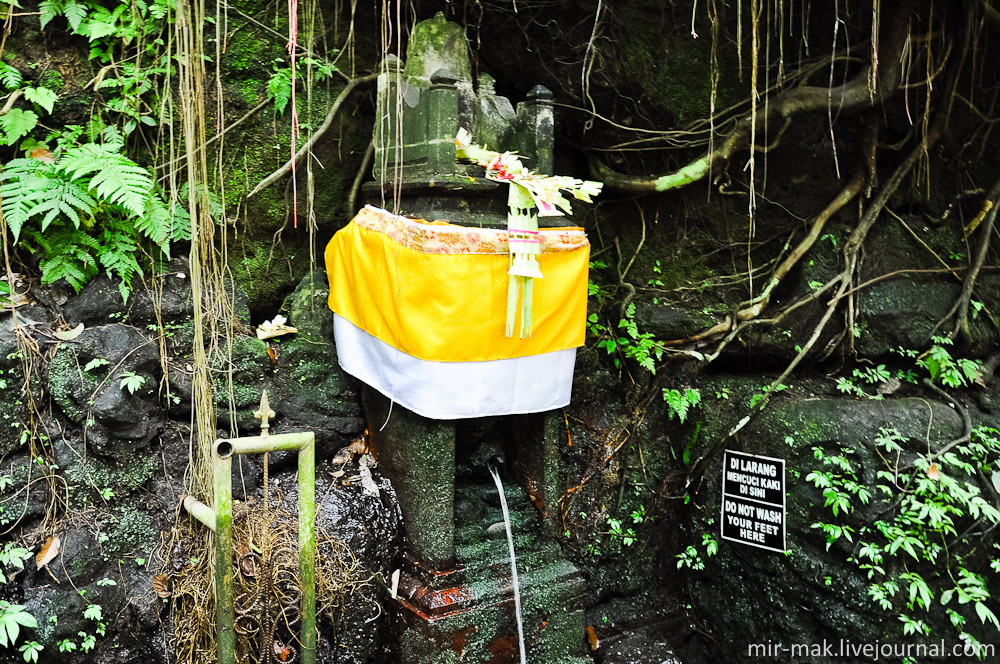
[326,207,590,362]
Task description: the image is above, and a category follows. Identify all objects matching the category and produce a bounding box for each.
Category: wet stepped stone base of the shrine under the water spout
[397,482,590,664]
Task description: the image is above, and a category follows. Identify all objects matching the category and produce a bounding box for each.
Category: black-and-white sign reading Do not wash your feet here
[722,450,785,552]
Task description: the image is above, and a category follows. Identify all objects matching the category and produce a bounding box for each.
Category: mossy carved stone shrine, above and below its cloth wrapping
[363,14,586,664]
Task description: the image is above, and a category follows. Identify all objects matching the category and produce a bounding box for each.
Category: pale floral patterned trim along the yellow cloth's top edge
[352,205,590,254]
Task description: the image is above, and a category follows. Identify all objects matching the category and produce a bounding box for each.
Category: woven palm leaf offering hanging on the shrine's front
[455,129,603,339]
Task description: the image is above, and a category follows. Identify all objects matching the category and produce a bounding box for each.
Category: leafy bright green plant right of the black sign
[807,427,1000,643]
